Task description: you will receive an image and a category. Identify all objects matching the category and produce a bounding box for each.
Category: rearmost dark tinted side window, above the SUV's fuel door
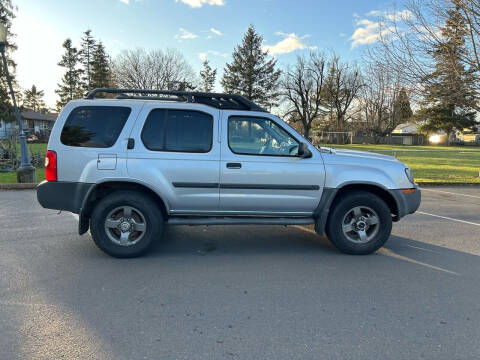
[60,106,132,148]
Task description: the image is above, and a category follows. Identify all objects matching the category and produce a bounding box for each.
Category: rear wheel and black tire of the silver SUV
[90,191,164,258]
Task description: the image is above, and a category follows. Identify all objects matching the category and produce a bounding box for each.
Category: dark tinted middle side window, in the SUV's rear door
[142,109,213,153]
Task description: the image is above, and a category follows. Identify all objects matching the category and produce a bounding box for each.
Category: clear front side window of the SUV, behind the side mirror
[228,116,299,156]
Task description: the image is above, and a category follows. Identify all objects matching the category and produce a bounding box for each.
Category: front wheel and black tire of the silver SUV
[326,191,392,255]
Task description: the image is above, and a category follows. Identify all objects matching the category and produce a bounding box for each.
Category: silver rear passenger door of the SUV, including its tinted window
[127,102,220,215]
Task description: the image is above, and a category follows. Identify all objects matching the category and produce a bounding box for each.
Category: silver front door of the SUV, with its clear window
[220,112,325,216]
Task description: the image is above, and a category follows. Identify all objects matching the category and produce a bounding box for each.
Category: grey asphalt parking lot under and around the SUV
[0,187,480,360]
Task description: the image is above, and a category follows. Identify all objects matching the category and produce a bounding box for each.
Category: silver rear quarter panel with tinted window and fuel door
[55,100,141,183]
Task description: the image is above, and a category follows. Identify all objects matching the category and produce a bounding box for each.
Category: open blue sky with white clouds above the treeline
[14,0,398,106]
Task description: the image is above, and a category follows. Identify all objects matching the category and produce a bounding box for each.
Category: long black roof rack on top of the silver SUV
[85,88,267,112]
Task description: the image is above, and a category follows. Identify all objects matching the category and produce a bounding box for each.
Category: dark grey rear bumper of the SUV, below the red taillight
[37,181,94,214]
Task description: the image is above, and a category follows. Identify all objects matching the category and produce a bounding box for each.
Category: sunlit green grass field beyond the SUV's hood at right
[332,145,480,184]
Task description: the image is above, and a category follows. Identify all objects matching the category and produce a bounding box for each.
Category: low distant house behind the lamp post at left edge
[0,109,58,139]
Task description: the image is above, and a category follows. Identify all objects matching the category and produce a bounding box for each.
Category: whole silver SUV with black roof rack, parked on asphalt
[37,89,420,257]
